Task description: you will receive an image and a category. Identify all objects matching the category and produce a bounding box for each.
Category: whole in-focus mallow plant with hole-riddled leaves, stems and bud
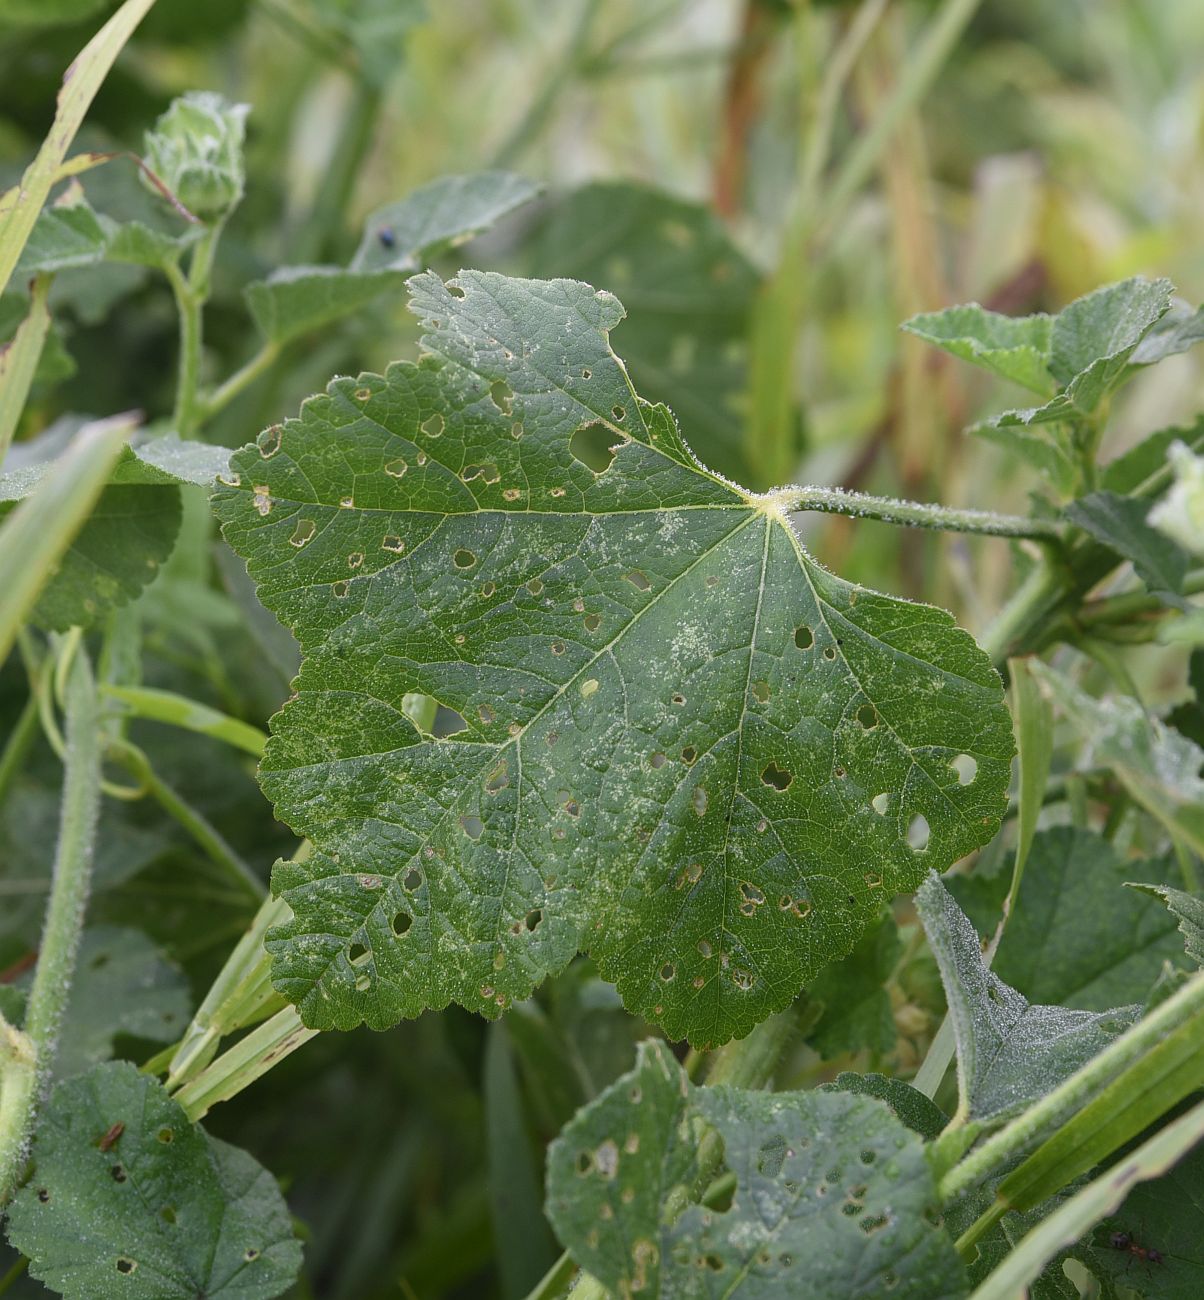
[0,0,1204,1300]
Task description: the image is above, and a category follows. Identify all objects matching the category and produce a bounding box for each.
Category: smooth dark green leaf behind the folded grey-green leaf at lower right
[948,827,1182,1011]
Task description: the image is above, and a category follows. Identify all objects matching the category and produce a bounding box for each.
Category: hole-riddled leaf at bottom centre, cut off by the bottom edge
[547,1043,966,1300]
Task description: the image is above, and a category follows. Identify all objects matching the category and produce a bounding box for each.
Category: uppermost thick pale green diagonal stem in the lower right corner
[937,972,1204,1203]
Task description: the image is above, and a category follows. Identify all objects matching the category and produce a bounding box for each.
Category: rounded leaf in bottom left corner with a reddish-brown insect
[8,1062,300,1300]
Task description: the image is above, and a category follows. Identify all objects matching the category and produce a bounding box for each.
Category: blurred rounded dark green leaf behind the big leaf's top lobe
[532,181,770,486]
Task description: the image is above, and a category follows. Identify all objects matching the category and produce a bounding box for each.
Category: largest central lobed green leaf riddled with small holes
[215,272,1013,1044]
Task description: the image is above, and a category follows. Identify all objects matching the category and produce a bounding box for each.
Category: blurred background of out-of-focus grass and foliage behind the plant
[0,0,1204,1300]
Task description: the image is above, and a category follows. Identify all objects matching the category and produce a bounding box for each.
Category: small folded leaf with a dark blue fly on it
[244,172,540,343]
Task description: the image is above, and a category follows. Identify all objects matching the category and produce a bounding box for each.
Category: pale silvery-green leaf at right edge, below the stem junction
[1032,662,1204,854]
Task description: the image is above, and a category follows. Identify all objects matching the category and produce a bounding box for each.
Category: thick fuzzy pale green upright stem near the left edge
[0,645,101,1205]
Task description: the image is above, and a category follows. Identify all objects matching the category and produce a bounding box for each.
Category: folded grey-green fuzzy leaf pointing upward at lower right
[915,874,1138,1125]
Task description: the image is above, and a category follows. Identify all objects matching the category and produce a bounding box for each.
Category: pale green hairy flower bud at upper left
[146,91,248,221]
